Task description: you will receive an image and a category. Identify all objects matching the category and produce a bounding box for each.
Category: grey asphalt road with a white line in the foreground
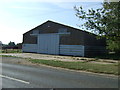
[0,58,118,88]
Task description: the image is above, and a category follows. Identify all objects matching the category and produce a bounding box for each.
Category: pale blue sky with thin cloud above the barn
[0,0,102,44]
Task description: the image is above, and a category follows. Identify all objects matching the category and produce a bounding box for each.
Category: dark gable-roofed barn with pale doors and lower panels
[22,20,106,56]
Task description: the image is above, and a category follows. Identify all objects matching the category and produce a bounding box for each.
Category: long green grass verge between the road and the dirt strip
[29,59,118,75]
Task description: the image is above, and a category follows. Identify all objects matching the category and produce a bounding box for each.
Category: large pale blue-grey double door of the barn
[38,34,59,54]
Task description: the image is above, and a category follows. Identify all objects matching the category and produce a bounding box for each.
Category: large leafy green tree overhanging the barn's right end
[74,2,120,53]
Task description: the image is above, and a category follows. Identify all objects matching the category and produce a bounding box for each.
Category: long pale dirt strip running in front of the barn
[0,53,118,64]
